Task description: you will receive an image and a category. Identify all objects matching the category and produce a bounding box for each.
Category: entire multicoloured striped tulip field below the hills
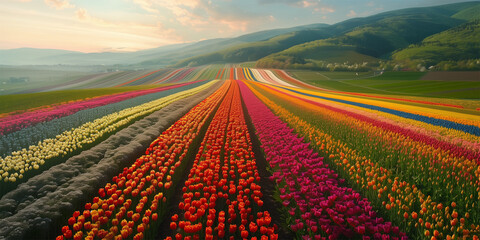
[0,65,480,240]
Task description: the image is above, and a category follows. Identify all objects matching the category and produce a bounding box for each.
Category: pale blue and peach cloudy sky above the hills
[0,0,472,52]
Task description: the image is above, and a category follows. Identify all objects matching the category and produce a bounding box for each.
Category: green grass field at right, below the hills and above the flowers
[291,71,480,99]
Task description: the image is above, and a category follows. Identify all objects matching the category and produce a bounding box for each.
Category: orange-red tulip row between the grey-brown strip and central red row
[57,81,229,239]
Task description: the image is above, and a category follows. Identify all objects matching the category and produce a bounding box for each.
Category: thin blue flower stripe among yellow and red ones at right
[281,87,480,136]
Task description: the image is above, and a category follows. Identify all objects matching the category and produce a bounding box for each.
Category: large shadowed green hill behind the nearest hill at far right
[257,2,480,71]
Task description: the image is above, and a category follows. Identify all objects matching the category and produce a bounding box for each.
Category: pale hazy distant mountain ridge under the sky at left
[0,24,325,67]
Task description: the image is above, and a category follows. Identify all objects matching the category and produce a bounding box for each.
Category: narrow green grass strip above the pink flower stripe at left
[0,85,163,113]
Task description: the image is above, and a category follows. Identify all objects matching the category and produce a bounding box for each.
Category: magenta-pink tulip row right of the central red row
[240,80,406,239]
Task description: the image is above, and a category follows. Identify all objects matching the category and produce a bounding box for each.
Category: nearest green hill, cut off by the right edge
[393,20,480,65]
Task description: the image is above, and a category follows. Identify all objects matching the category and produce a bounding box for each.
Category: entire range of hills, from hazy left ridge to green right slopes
[0,1,480,70]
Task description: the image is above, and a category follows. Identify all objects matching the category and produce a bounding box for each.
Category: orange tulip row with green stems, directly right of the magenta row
[244,80,480,239]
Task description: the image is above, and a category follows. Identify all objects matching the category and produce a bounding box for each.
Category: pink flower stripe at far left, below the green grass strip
[0,82,202,135]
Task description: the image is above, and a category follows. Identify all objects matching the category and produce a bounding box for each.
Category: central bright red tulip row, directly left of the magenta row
[167,82,278,239]
